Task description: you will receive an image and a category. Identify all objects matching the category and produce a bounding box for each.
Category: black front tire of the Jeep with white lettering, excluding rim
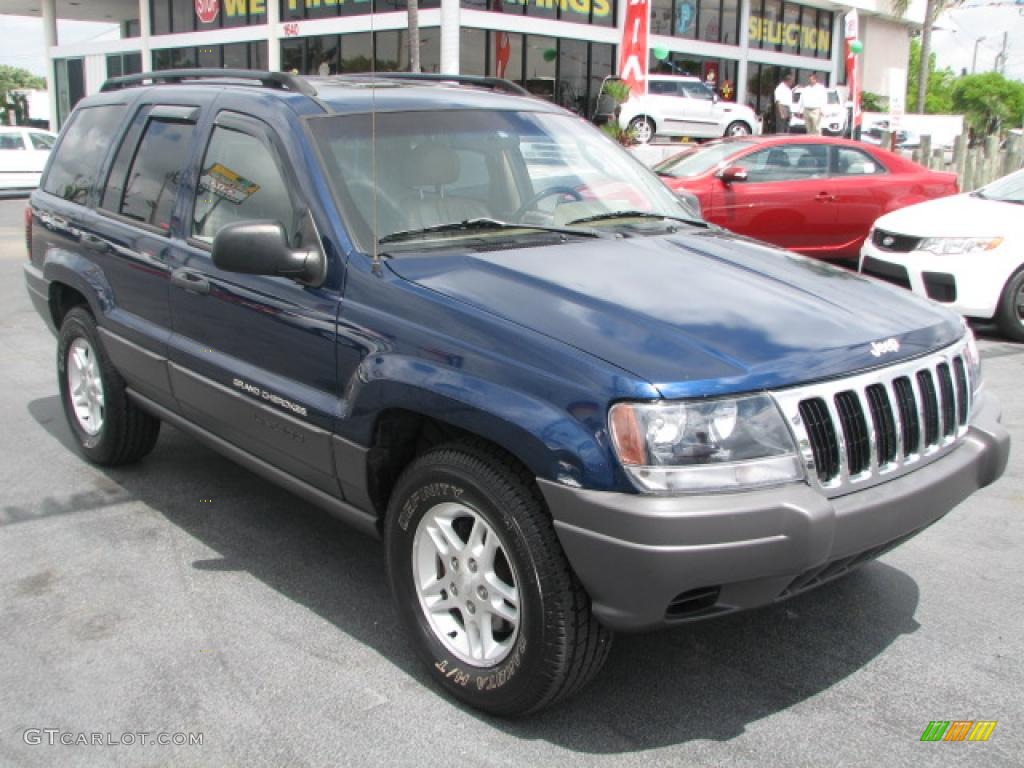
[385,441,611,716]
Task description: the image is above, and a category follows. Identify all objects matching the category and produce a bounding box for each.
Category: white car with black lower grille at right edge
[860,170,1024,341]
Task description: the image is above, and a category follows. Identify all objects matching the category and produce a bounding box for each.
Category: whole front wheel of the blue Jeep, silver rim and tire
[385,442,611,716]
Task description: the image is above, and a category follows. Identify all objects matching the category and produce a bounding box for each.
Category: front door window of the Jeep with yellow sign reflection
[193,126,295,243]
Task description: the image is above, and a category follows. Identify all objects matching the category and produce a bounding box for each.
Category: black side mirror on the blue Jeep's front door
[213,221,327,286]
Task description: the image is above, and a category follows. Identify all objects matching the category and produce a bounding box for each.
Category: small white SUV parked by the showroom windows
[618,75,761,144]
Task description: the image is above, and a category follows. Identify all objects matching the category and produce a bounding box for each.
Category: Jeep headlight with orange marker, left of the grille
[608,394,804,493]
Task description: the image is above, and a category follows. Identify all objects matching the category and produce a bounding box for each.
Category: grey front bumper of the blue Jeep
[540,394,1010,632]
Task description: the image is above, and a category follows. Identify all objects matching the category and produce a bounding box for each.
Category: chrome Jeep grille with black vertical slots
[774,341,973,497]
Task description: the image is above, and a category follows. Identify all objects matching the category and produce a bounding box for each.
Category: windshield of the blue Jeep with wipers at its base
[310,110,692,252]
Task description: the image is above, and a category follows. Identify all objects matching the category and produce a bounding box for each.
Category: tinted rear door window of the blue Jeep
[101,119,196,231]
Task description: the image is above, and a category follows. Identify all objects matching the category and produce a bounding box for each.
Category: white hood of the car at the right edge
[874,195,1024,238]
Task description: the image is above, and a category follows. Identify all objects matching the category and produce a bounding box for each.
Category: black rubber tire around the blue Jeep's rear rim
[57,307,160,466]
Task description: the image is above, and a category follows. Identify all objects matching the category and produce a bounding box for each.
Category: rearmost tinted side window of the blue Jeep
[43,104,128,203]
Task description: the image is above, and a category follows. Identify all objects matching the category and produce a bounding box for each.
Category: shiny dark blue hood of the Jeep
[387,230,963,397]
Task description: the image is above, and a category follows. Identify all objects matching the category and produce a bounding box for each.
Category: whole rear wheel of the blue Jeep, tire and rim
[57,307,160,465]
